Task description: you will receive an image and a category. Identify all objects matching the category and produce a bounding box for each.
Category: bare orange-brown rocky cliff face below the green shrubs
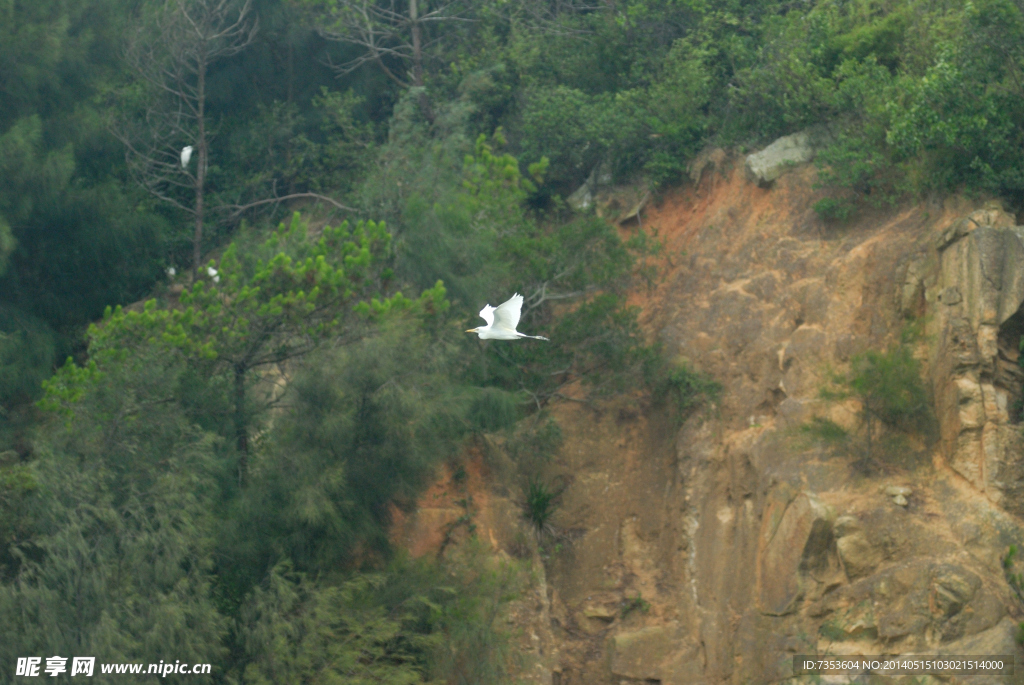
[407,153,1024,685]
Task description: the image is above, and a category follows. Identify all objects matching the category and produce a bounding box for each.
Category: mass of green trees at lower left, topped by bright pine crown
[0,206,544,683]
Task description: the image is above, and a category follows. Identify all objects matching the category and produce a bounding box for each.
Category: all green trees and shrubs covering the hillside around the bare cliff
[0,0,1024,684]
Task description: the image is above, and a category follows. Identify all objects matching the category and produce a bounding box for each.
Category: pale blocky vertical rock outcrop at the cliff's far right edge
[932,210,1024,515]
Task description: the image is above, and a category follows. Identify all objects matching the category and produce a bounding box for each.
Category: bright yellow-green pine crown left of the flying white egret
[40,213,415,436]
